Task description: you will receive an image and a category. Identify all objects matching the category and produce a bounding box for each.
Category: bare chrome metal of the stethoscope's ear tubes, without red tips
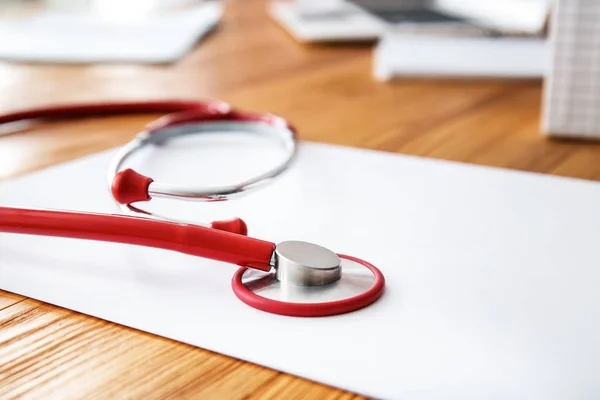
[106,121,296,220]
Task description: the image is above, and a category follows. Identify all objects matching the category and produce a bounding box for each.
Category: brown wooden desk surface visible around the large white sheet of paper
[0,1,600,399]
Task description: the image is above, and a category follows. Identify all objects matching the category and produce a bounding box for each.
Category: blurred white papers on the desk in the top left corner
[0,2,222,63]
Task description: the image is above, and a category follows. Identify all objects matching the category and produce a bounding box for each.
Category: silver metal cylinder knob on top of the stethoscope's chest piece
[274,241,342,286]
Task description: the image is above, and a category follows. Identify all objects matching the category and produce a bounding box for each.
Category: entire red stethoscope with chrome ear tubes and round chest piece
[0,101,385,317]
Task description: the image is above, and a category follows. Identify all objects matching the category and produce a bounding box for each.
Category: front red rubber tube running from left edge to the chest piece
[0,207,275,271]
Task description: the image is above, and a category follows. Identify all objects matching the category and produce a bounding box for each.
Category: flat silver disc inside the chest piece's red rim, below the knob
[242,258,375,304]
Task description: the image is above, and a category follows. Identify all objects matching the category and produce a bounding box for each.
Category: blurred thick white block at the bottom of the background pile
[373,32,547,80]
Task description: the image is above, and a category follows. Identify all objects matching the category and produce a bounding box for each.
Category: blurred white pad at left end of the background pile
[267,0,384,42]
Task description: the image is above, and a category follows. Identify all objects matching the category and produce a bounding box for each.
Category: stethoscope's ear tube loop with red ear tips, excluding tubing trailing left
[107,101,296,234]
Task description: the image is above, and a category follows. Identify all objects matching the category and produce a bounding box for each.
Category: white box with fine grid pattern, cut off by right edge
[542,0,600,139]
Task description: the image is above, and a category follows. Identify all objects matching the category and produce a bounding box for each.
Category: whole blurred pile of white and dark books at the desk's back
[269,0,551,80]
